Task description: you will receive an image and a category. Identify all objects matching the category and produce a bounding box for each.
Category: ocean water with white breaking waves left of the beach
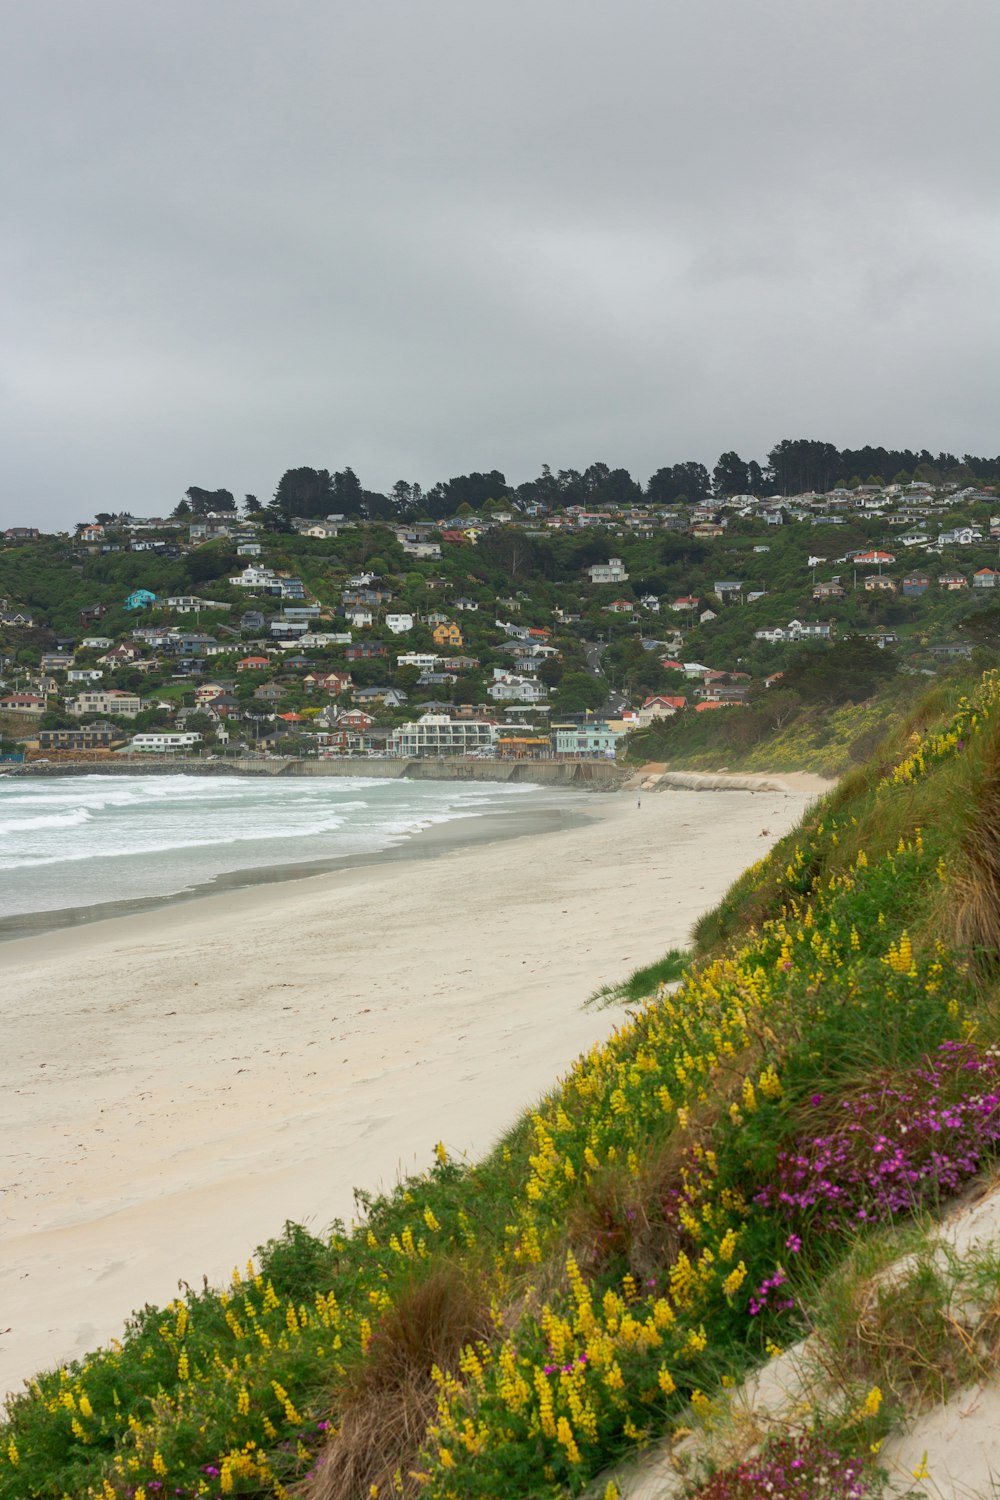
[0,776,550,921]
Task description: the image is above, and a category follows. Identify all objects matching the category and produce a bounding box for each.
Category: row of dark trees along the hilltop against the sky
[174,438,1000,531]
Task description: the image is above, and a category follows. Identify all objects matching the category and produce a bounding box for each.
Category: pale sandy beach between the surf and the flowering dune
[0,777,826,1392]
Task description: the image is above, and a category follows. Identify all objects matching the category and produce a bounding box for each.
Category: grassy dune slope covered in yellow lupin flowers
[0,680,1000,1500]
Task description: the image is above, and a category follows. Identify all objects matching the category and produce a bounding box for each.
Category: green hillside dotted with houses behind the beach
[0,461,1000,770]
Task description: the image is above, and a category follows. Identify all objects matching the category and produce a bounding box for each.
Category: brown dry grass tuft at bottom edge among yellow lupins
[305,1266,490,1500]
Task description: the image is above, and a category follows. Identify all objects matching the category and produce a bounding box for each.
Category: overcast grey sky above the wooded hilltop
[0,0,1000,527]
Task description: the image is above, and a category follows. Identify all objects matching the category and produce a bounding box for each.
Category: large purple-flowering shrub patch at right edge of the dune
[756,1041,1000,1230]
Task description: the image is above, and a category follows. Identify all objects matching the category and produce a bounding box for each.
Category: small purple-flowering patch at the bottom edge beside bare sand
[696,1434,873,1500]
